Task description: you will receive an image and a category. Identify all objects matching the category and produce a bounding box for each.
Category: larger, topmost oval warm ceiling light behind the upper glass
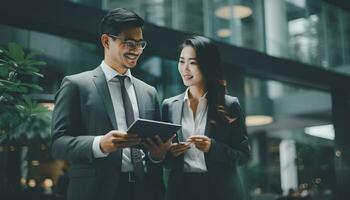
[215,5,253,20]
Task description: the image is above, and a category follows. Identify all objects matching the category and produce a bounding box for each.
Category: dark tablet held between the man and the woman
[127,119,181,141]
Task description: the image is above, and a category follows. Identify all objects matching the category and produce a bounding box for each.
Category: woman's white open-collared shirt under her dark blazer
[181,89,208,173]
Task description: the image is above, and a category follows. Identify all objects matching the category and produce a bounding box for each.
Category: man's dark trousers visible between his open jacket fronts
[114,173,163,200]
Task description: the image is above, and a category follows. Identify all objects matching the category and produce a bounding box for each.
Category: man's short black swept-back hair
[100,8,145,35]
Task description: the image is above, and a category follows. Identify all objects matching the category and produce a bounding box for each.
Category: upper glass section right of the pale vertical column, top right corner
[286,0,350,73]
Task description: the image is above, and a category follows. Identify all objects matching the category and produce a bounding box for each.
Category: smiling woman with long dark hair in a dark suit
[162,36,250,200]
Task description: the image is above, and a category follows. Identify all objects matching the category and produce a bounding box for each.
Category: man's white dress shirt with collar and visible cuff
[92,61,146,172]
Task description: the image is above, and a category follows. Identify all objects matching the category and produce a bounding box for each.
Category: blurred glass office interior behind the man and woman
[0,0,350,200]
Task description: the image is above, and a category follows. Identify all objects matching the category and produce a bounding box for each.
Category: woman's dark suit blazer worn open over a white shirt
[162,93,250,200]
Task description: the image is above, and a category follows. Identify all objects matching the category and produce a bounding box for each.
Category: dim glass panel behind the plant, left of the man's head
[0,25,102,94]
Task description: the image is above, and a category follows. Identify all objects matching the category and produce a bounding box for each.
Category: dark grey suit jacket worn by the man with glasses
[51,67,164,200]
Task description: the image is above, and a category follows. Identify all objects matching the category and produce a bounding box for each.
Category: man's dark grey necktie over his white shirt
[117,76,145,180]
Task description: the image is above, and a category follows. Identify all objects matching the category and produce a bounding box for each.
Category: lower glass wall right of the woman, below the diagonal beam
[245,78,335,199]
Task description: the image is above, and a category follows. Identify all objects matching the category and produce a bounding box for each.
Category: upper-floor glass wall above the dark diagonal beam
[67,0,350,74]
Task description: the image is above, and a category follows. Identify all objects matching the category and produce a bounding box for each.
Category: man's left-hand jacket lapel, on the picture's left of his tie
[93,67,118,130]
